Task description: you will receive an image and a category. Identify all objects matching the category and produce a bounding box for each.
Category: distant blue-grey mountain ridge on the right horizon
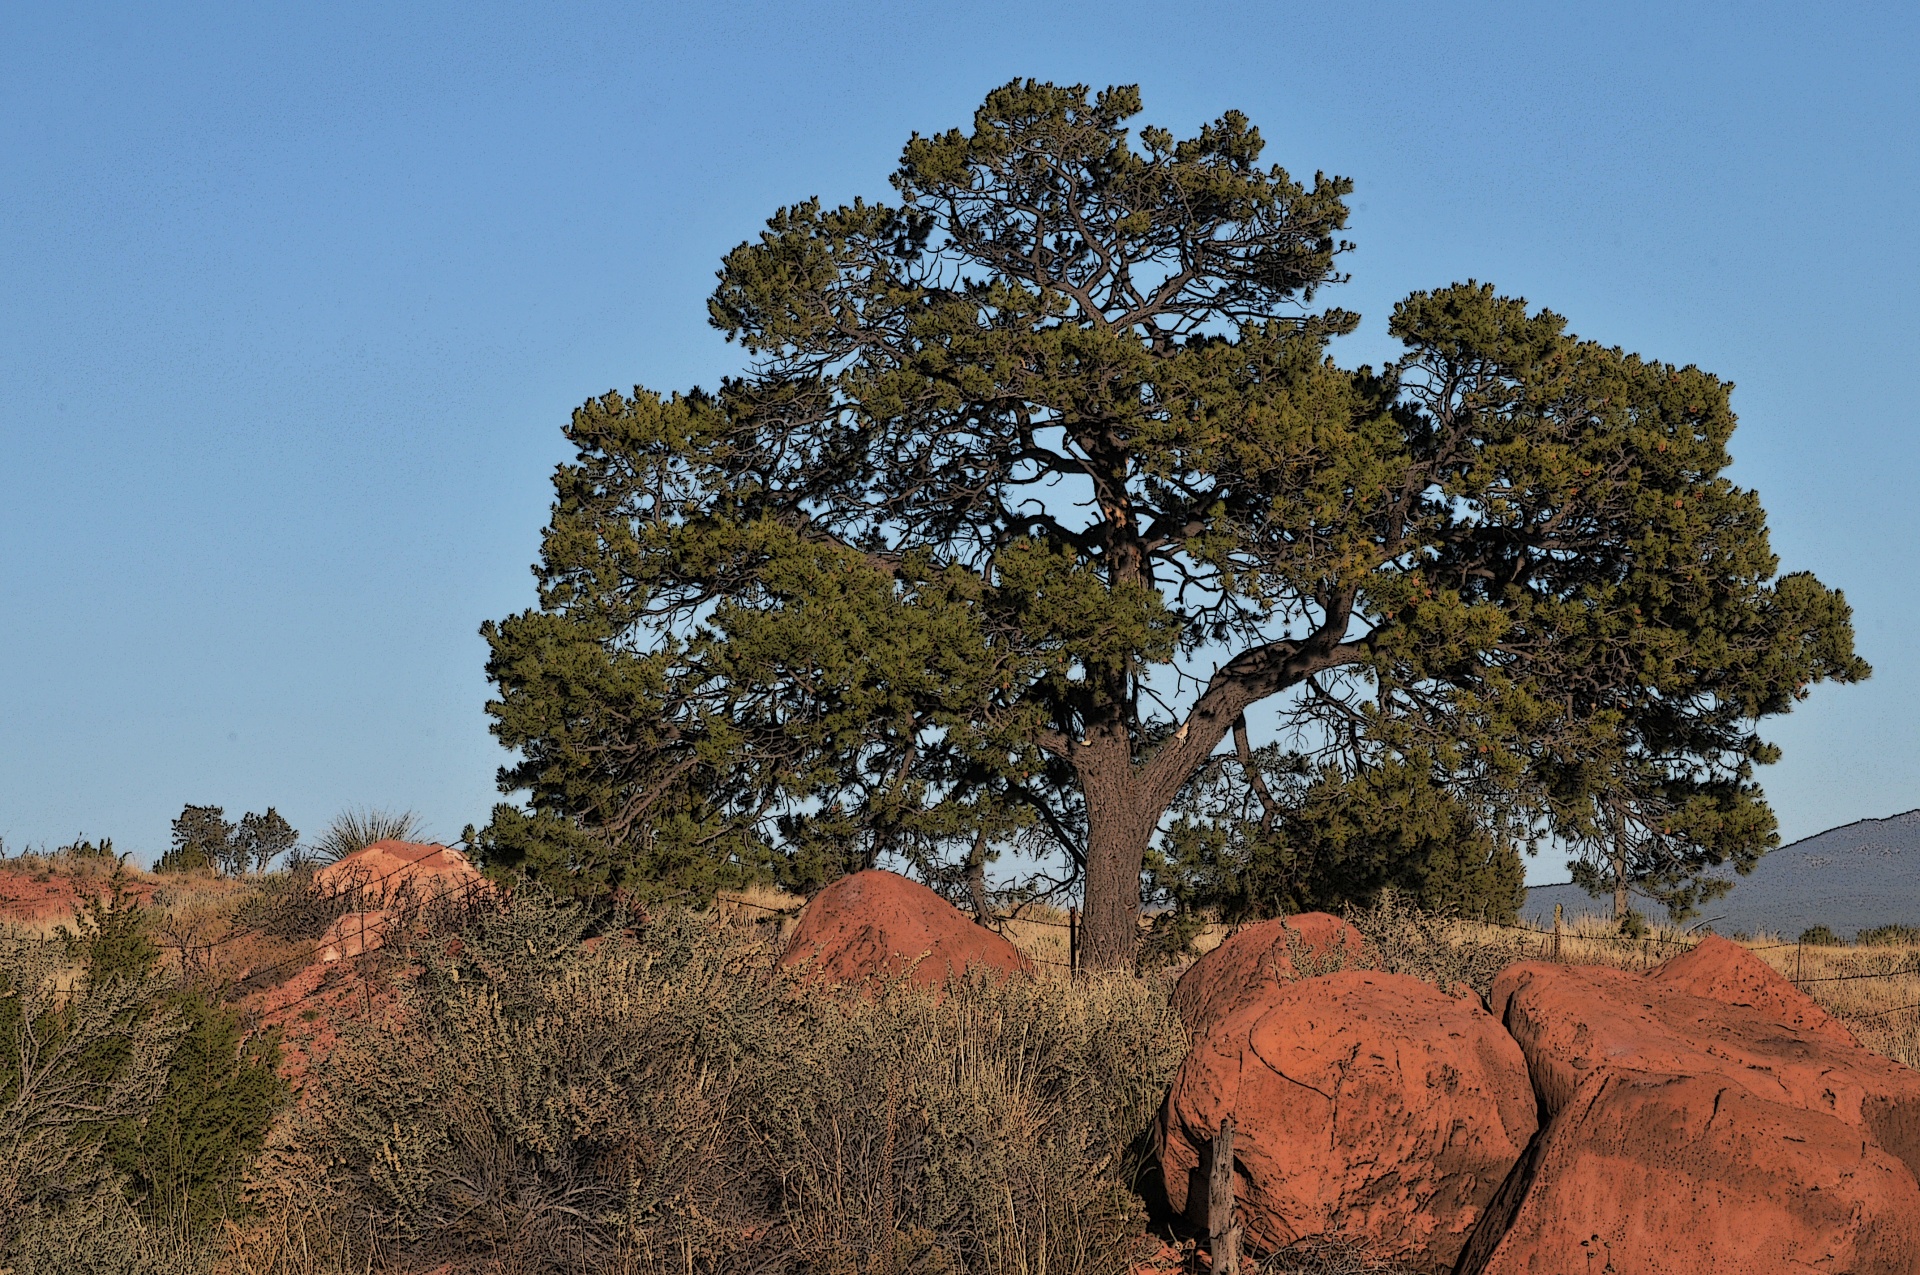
[1521,810,1920,939]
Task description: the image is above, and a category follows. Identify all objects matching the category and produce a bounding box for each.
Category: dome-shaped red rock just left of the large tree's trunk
[781,870,1033,987]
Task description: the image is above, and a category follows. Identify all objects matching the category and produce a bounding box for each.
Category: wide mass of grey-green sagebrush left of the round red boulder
[278,899,1185,1275]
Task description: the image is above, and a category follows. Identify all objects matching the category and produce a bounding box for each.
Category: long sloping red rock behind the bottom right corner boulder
[1494,962,1920,1173]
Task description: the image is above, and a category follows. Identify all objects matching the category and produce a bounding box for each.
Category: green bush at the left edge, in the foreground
[0,864,286,1271]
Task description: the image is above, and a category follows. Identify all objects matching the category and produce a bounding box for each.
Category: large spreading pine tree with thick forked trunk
[484,81,1868,964]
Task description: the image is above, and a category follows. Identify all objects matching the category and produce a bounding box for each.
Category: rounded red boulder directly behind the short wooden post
[1160,970,1536,1271]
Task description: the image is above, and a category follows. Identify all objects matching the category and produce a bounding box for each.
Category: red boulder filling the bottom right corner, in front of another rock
[1461,1070,1920,1275]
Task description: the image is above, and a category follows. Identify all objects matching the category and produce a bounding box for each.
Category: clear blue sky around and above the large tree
[0,2,1920,879]
